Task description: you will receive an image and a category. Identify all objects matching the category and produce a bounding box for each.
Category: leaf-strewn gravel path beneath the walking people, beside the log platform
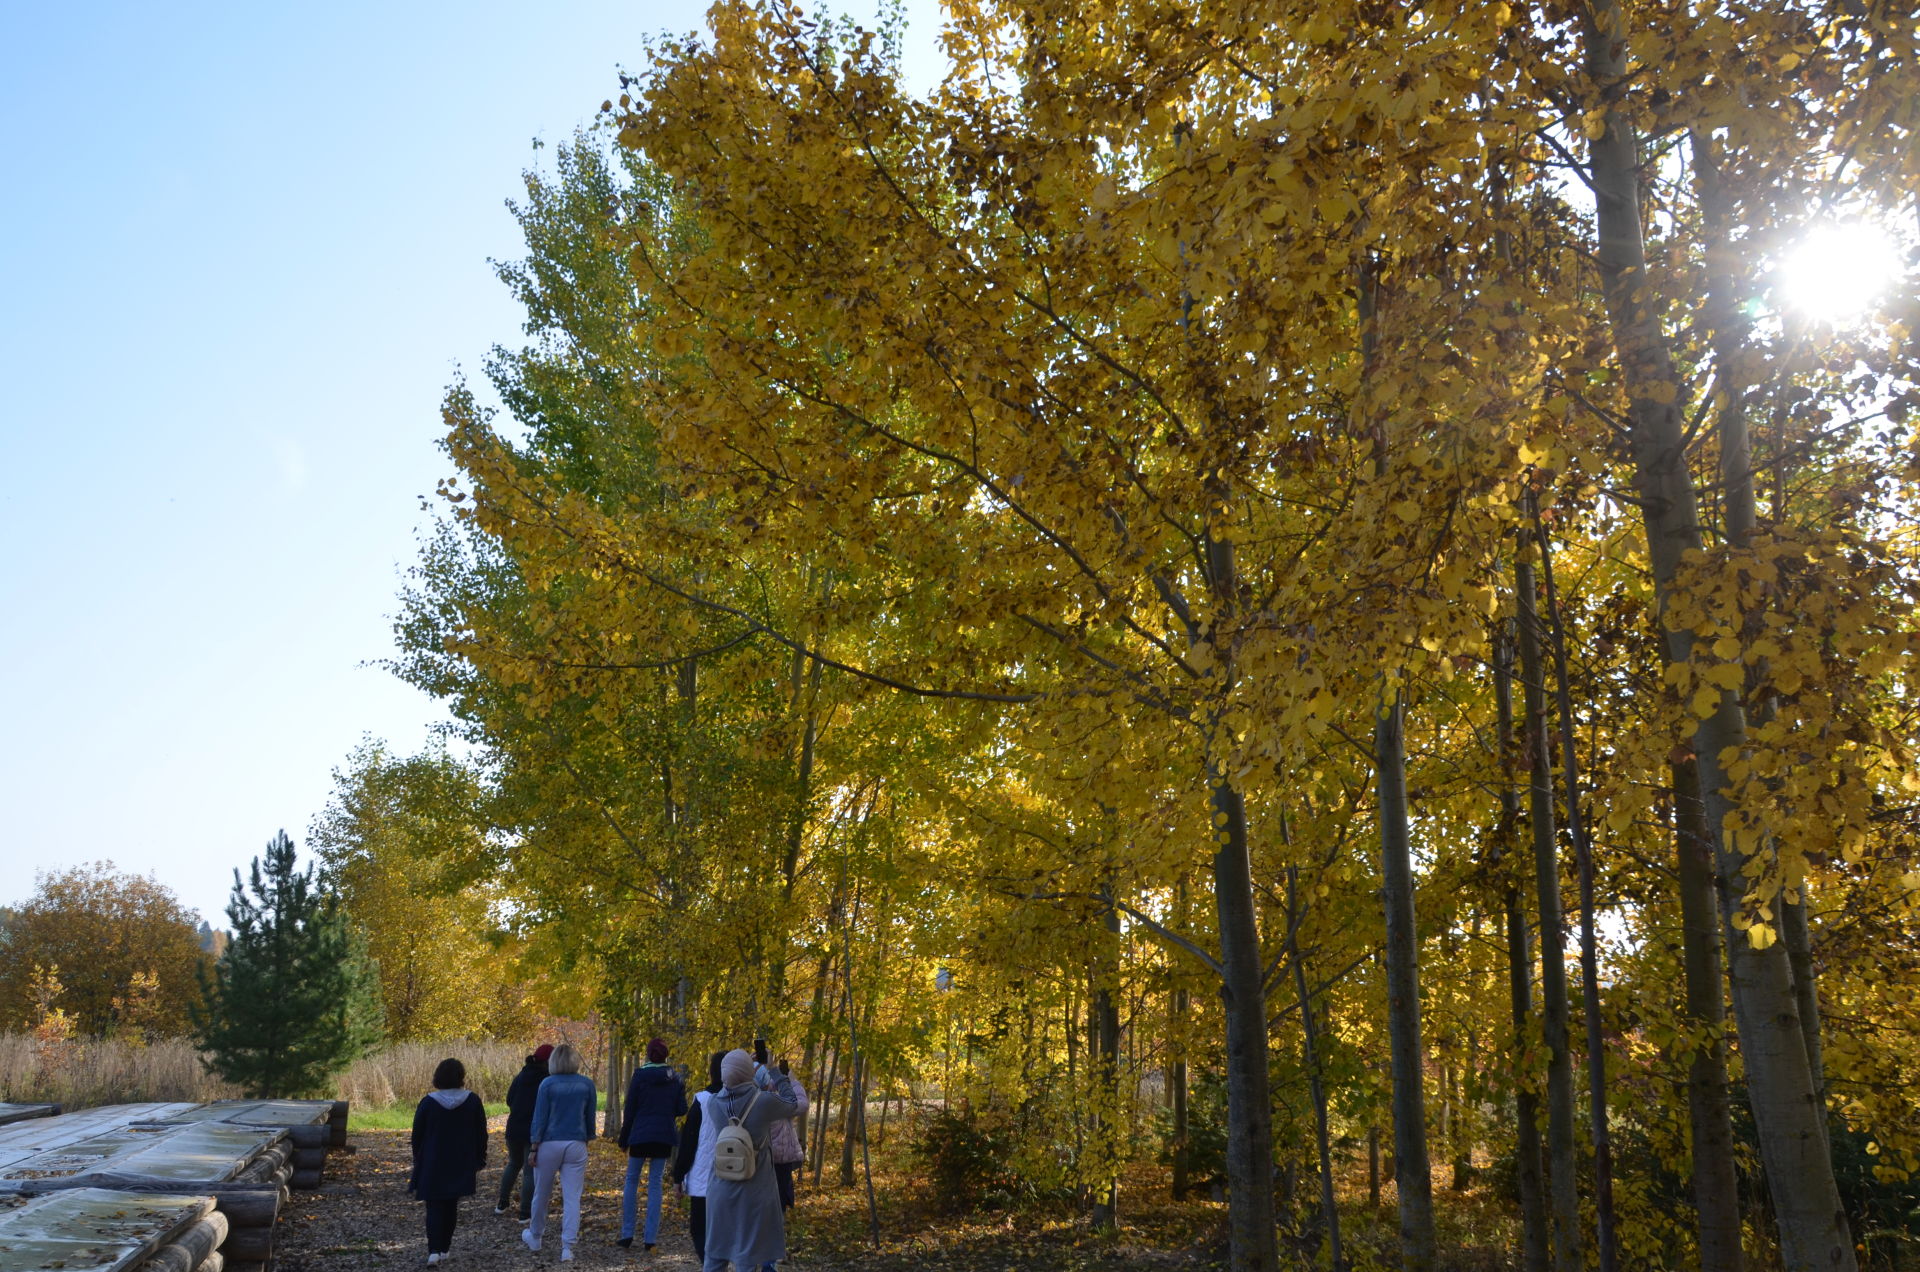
[276,1126,699,1272]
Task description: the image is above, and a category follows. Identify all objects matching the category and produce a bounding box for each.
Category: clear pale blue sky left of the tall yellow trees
[0,0,935,922]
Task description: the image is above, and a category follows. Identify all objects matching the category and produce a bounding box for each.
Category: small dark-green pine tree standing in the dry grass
[194,830,384,1095]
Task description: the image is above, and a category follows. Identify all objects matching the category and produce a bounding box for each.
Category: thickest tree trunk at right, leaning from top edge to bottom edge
[1584,0,1857,1272]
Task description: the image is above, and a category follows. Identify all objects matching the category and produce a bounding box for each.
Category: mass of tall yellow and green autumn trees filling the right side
[382,0,1920,1270]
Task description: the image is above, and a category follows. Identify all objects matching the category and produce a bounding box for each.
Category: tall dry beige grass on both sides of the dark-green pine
[0,1034,526,1109]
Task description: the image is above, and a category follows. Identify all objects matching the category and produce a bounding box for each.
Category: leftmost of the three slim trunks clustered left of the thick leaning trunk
[1494,621,1549,1272]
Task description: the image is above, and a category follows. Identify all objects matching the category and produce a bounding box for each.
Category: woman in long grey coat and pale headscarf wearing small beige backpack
[703,1049,801,1272]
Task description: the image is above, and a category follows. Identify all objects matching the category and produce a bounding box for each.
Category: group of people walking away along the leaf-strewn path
[407,1038,806,1272]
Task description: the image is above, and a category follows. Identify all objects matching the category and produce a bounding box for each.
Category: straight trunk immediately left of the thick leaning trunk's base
[1672,759,1745,1272]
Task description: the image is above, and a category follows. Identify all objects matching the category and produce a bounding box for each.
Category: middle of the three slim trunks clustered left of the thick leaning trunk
[1513,561,1584,1272]
